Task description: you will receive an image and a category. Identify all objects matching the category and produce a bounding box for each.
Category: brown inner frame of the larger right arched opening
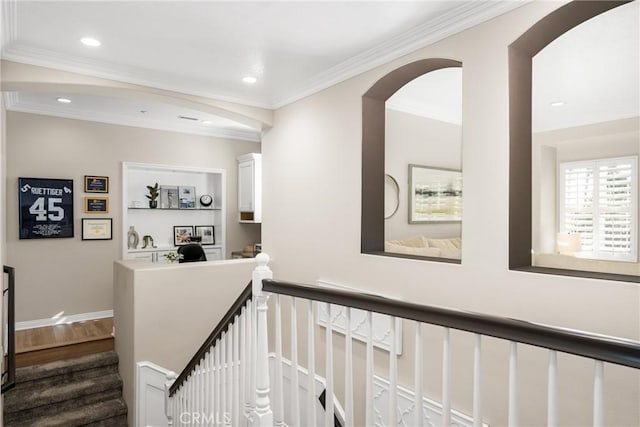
[509,1,638,281]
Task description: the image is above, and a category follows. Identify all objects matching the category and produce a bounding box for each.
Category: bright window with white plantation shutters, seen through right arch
[559,157,638,262]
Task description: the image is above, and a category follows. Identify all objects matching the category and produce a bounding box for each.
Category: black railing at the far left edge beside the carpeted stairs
[0,265,16,393]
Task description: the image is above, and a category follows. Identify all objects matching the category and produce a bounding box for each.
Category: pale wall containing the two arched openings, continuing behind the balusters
[262,2,640,425]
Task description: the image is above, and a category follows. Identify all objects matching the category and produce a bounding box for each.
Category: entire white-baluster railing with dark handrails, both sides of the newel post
[166,253,640,427]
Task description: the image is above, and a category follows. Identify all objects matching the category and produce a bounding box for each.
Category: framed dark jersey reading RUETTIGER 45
[18,178,73,239]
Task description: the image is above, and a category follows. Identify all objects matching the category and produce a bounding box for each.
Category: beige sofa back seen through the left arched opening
[384,235,462,259]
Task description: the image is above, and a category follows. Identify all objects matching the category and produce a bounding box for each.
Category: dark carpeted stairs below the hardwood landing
[4,351,127,427]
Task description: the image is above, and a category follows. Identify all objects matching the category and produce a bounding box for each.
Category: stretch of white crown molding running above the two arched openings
[271,0,533,109]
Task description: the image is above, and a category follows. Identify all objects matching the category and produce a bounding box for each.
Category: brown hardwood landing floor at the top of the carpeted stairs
[16,317,114,367]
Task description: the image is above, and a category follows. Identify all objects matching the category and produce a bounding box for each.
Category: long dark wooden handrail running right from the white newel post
[262,279,640,369]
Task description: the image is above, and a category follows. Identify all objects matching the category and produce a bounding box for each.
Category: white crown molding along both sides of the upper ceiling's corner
[2,0,533,109]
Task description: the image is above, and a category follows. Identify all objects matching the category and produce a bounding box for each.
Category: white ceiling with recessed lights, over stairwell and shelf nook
[2,0,527,140]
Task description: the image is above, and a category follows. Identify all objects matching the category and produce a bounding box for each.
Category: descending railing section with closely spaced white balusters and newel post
[165,254,273,427]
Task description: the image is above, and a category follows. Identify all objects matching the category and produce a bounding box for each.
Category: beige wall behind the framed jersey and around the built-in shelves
[6,112,260,321]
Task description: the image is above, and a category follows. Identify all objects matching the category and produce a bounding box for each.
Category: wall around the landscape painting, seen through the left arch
[384,109,462,240]
